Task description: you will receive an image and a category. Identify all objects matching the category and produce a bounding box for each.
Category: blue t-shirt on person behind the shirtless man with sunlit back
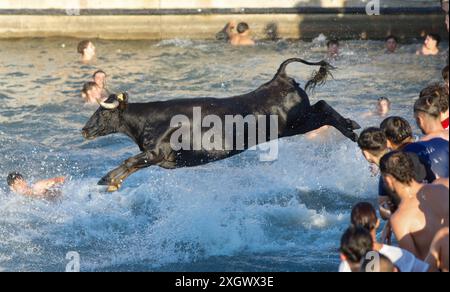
[378,138,449,197]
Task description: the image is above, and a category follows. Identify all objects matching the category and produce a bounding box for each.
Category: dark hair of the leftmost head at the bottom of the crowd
[340,226,373,264]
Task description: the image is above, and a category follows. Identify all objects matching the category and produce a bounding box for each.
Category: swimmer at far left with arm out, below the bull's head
[7,172,66,200]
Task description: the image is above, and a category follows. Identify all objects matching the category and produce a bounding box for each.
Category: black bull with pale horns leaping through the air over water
[83,58,360,191]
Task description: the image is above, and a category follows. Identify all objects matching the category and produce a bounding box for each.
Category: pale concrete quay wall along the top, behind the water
[0,0,448,40]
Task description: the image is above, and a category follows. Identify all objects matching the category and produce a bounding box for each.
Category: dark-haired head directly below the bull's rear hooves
[358,128,388,165]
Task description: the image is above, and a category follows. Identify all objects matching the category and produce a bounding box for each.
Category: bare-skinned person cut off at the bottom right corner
[426,228,449,273]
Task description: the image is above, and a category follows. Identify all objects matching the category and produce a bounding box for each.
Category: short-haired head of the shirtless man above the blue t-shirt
[414,96,441,135]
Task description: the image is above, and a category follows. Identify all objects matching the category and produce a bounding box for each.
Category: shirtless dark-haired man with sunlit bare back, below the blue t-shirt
[380,152,449,260]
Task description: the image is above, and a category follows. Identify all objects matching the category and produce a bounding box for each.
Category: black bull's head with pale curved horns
[82,93,128,140]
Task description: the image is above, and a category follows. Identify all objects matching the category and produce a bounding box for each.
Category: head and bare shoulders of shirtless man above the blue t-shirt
[414,96,449,141]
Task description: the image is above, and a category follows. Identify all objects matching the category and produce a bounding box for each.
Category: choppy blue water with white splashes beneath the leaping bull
[0,39,447,271]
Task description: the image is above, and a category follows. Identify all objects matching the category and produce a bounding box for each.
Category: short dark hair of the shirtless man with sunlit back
[380,152,416,184]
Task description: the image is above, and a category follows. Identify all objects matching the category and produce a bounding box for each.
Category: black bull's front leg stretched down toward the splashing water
[98,151,162,192]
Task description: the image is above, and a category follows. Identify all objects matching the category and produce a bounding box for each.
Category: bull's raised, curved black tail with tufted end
[275,58,335,90]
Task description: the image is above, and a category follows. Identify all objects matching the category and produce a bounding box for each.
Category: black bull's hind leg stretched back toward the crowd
[307,101,361,142]
